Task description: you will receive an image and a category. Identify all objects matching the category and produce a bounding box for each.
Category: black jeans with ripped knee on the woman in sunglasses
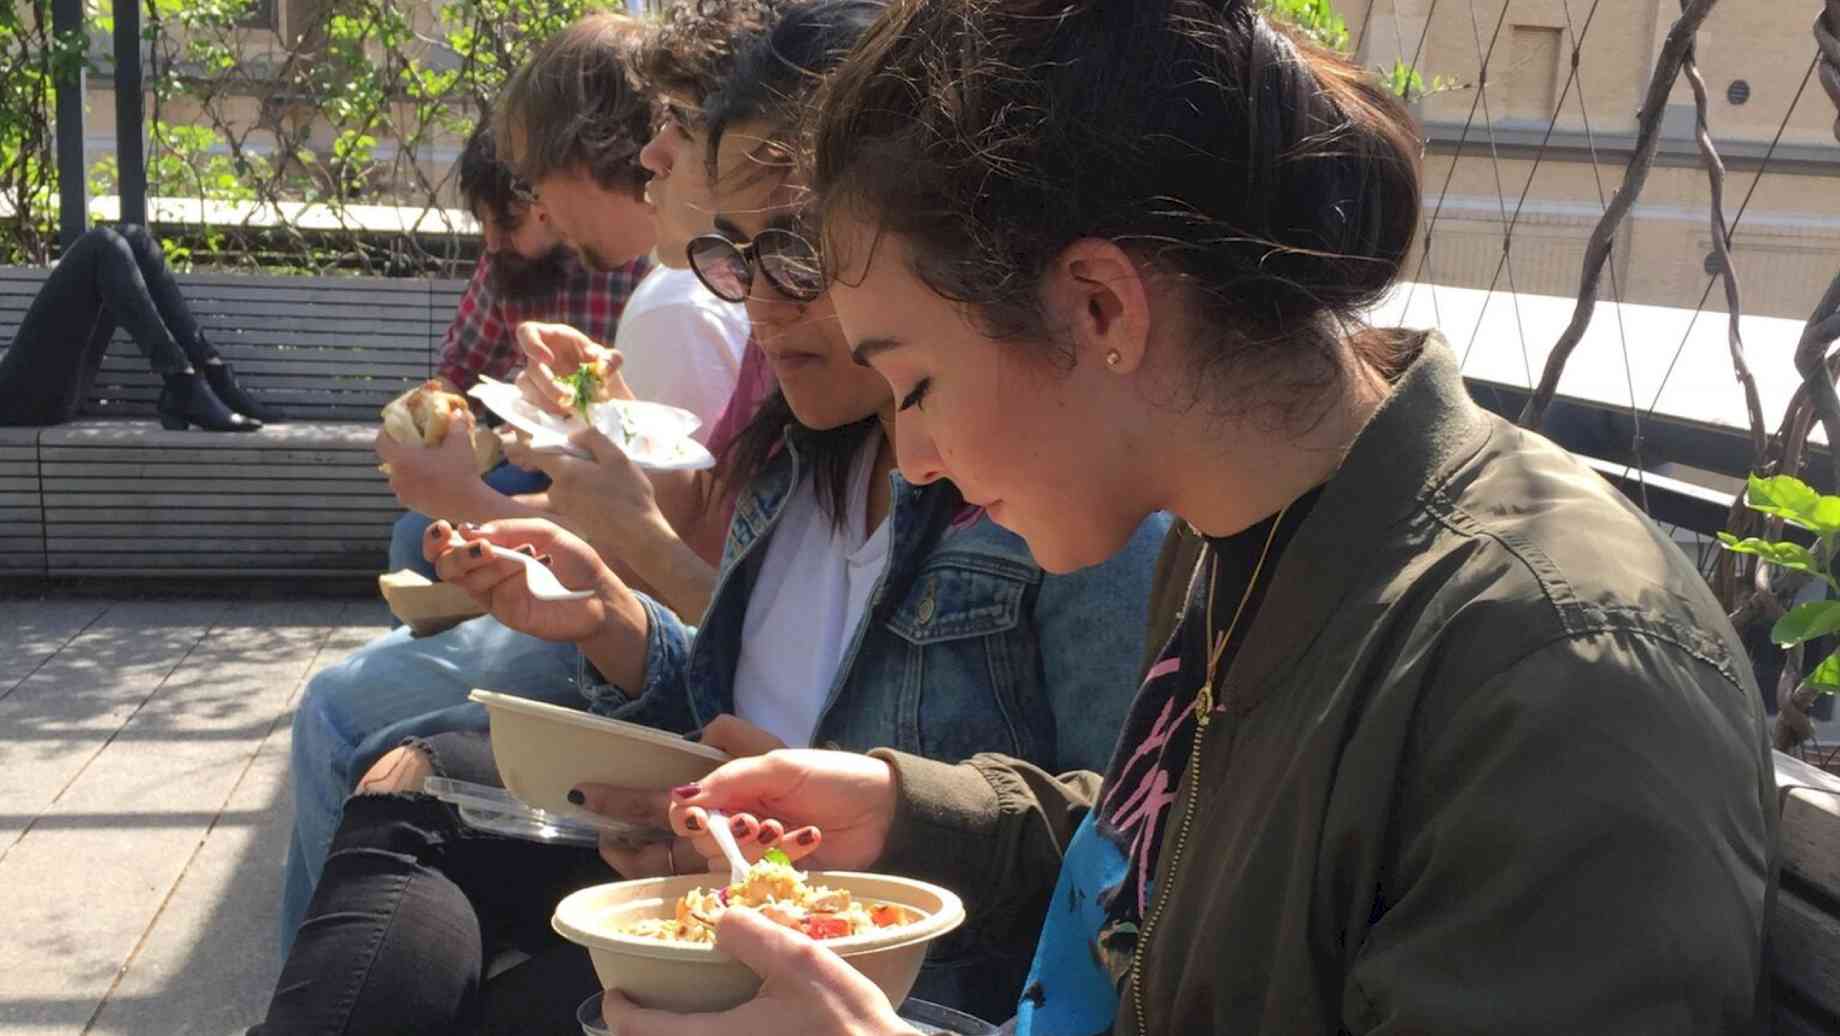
[248,734,616,1036]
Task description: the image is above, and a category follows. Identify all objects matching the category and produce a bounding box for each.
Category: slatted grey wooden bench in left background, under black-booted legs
[0,267,466,576]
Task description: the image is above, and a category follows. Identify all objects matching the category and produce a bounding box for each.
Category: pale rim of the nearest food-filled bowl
[550,870,964,964]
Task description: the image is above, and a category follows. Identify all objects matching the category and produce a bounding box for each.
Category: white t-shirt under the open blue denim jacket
[734,436,889,749]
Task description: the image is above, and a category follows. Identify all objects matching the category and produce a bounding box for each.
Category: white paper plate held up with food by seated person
[467,377,716,471]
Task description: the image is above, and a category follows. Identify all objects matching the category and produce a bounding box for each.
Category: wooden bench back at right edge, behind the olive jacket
[1770,753,1840,1036]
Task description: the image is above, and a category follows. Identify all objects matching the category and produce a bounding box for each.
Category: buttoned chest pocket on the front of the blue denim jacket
[883,554,1054,760]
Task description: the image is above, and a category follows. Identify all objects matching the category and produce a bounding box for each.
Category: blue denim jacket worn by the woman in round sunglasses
[580,432,1168,1018]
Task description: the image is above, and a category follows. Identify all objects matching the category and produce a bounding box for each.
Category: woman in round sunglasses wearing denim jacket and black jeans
[252,0,1168,1032]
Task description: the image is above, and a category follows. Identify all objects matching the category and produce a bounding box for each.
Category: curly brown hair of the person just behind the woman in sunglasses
[633,0,795,118]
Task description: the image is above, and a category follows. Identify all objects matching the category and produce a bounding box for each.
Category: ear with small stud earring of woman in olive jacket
[1043,237,1150,374]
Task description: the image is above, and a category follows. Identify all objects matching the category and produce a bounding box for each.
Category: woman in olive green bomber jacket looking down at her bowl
[605,0,1774,1036]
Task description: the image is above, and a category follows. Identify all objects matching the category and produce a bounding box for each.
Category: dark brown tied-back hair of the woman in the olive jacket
[810,0,1420,420]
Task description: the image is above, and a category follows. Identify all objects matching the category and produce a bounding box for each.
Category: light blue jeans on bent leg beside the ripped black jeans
[282,616,587,957]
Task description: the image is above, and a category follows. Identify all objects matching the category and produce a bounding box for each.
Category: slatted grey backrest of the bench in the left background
[0,267,466,421]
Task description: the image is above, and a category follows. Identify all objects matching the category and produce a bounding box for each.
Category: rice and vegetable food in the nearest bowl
[626,848,920,944]
